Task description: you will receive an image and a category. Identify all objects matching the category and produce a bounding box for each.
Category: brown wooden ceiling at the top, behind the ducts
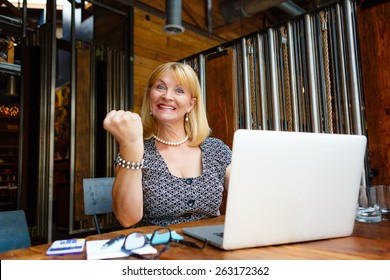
[94,0,336,41]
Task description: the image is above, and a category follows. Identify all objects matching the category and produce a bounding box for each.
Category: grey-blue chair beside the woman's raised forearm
[83,177,114,234]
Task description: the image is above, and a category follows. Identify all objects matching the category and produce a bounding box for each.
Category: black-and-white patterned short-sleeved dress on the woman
[136,138,232,226]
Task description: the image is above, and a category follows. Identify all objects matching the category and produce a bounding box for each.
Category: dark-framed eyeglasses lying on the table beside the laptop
[122,228,207,259]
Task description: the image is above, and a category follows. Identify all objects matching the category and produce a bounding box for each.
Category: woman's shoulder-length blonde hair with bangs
[141,62,211,146]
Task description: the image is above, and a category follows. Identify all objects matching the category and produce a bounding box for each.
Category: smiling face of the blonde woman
[150,71,196,124]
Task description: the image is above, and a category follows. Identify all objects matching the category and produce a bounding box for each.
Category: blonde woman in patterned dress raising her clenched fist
[103,62,231,227]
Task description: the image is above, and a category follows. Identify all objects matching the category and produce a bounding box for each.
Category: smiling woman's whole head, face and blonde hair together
[141,62,211,142]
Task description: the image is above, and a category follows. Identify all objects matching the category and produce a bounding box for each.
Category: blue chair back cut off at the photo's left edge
[0,210,31,252]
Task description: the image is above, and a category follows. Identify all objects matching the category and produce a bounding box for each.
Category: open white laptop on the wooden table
[183,129,367,250]
